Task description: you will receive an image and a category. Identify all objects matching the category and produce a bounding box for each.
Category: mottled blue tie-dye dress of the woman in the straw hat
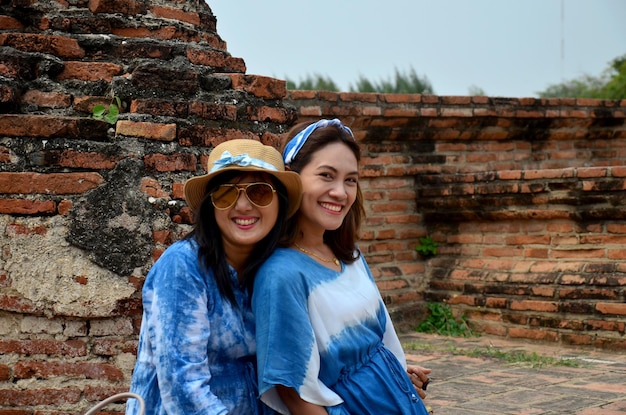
[126,240,273,415]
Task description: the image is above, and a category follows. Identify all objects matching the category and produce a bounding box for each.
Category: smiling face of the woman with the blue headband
[298,142,359,234]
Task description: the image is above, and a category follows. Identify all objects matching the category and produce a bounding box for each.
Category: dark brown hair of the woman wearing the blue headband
[280,122,365,263]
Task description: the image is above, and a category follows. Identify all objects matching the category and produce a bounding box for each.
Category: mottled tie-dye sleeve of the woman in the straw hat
[147,245,227,415]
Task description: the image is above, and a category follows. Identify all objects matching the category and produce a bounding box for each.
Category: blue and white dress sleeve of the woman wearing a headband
[252,261,343,414]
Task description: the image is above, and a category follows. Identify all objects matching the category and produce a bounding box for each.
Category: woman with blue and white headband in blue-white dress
[252,119,429,415]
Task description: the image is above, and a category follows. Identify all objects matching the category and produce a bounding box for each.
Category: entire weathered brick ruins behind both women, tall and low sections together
[0,0,626,415]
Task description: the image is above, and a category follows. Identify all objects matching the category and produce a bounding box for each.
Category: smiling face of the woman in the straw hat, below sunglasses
[215,173,279,253]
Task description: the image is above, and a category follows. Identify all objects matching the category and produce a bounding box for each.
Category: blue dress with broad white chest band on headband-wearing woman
[252,248,428,415]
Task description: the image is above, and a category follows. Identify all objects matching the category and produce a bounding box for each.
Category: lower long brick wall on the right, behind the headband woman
[288,91,626,350]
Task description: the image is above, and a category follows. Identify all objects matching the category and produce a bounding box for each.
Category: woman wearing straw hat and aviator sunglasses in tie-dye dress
[126,139,302,414]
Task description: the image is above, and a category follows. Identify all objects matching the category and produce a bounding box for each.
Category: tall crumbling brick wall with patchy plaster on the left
[0,0,297,415]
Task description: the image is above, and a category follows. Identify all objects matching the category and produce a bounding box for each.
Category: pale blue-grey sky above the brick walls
[207,0,626,97]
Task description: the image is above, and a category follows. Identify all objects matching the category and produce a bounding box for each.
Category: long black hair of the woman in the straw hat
[185,170,287,306]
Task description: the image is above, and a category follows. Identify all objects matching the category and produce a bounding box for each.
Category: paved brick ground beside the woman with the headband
[400,333,626,415]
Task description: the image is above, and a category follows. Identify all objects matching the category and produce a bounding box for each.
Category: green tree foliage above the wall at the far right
[538,55,626,99]
